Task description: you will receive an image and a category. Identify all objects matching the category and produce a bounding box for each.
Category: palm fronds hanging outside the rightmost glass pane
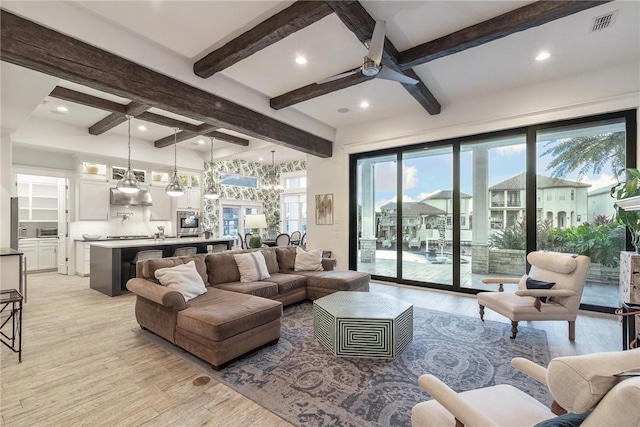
[542,132,625,182]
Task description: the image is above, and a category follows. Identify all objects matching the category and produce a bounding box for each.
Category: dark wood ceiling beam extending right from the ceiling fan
[398,0,611,70]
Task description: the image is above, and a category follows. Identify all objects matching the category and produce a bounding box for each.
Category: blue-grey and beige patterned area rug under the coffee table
[135,302,551,427]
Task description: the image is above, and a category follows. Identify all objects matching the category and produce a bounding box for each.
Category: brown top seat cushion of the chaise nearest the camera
[177,288,282,341]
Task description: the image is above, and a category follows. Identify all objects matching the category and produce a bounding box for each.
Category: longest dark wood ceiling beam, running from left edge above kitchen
[0,10,333,157]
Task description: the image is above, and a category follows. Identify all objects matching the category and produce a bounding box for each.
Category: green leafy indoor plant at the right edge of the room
[611,168,640,253]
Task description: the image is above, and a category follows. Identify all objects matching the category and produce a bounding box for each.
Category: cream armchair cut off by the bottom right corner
[411,349,640,427]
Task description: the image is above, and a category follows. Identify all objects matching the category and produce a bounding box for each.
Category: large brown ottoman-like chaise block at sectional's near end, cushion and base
[175,288,282,370]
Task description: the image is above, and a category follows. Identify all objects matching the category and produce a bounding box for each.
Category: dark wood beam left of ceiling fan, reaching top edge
[193,1,332,78]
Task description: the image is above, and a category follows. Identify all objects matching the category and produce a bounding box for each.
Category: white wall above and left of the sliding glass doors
[307,62,640,269]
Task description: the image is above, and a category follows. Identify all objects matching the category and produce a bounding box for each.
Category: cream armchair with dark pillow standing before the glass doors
[477,252,591,341]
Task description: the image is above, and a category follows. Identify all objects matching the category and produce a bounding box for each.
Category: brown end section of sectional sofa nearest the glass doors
[307,271,371,300]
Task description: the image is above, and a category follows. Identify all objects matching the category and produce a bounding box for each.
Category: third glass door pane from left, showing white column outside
[460,135,526,290]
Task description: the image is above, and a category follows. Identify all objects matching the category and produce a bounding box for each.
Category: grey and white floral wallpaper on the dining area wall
[202,160,307,236]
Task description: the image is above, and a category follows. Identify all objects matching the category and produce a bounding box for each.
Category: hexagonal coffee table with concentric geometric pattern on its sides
[313,291,413,358]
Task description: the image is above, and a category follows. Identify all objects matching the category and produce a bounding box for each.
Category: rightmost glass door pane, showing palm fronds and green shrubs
[536,119,626,307]
